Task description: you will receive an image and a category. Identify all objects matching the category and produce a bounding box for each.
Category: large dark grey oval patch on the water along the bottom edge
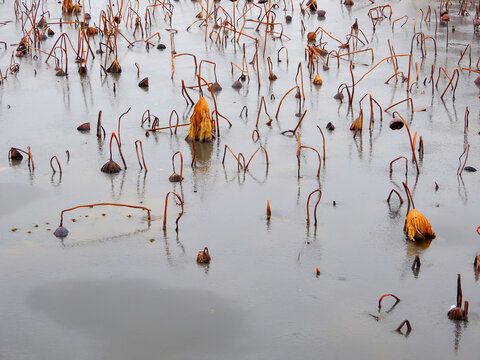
[27,278,256,360]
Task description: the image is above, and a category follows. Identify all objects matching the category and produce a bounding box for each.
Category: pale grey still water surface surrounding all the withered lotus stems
[0,0,480,359]
